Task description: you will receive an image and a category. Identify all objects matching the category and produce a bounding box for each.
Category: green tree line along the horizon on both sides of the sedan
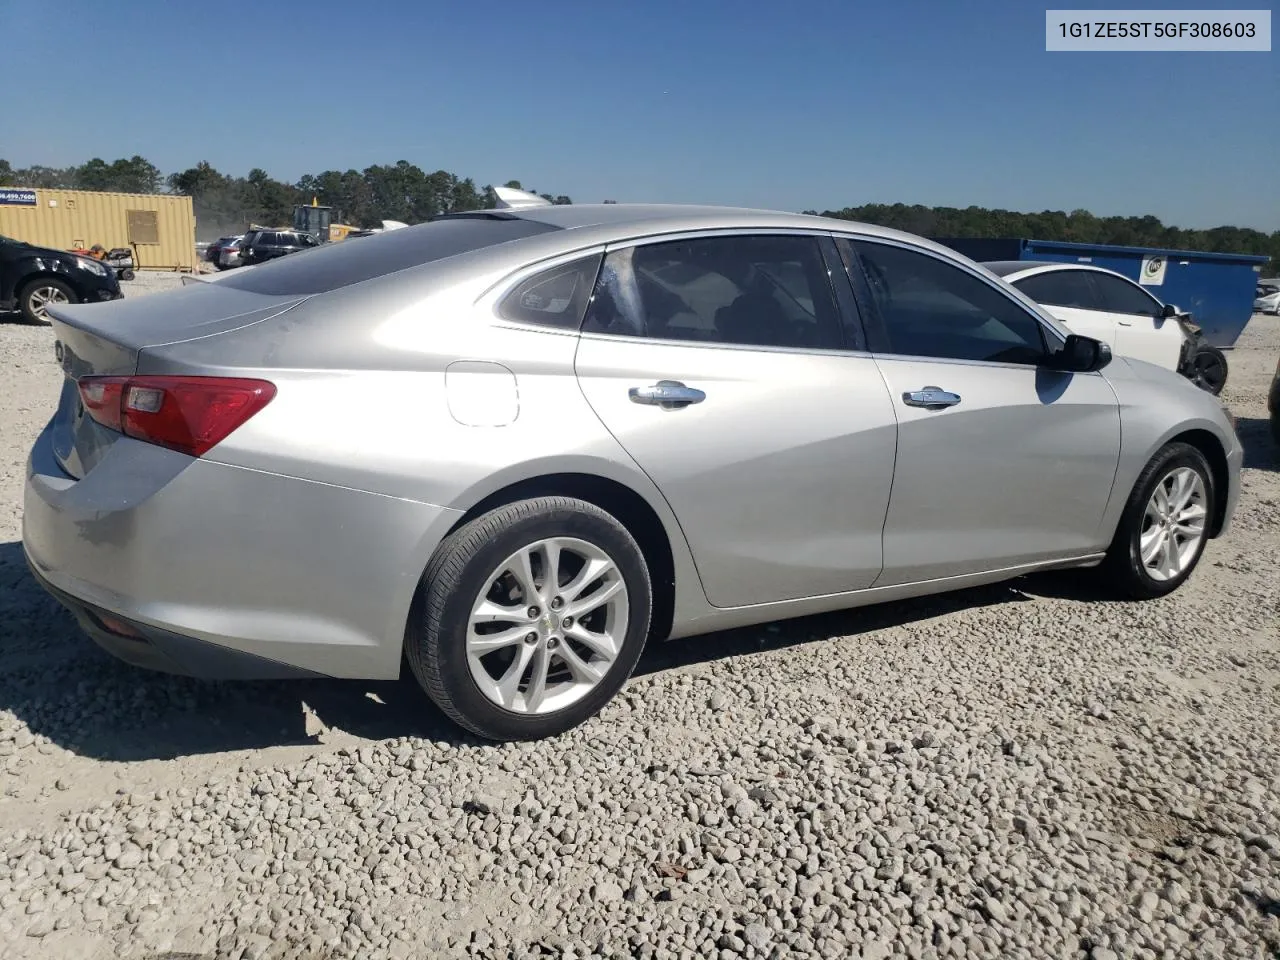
[0,156,1280,275]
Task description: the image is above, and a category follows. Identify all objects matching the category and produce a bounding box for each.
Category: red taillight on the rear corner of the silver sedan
[79,376,275,457]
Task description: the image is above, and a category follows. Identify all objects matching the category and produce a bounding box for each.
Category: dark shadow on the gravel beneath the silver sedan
[0,543,1084,762]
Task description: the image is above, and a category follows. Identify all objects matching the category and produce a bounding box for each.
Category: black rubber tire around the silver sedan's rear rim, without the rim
[404,497,653,740]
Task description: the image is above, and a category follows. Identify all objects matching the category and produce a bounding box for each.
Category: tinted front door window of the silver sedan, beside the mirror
[840,239,1046,364]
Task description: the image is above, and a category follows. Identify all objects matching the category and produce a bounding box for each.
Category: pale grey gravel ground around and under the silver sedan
[0,276,1280,960]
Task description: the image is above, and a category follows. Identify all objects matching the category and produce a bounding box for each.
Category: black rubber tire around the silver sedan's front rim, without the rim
[1098,443,1217,600]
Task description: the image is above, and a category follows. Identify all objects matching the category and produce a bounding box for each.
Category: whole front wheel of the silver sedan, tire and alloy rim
[1100,443,1215,600]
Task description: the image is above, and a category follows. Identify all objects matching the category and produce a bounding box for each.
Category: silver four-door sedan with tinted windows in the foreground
[23,204,1243,739]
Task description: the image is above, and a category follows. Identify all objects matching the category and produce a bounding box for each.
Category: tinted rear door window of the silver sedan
[582,236,844,349]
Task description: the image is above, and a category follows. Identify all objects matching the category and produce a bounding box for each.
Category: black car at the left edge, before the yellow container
[0,237,124,324]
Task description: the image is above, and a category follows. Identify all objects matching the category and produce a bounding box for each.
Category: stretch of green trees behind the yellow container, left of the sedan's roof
[0,156,572,239]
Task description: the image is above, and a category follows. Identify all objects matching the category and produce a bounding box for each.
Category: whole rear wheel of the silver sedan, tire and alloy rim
[406,497,653,740]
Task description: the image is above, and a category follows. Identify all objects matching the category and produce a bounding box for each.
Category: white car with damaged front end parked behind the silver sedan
[983,260,1228,394]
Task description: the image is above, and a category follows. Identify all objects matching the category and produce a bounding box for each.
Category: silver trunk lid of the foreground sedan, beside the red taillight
[50,283,306,480]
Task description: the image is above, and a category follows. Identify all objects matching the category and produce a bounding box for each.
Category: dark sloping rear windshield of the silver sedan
[218,218,561,297]
